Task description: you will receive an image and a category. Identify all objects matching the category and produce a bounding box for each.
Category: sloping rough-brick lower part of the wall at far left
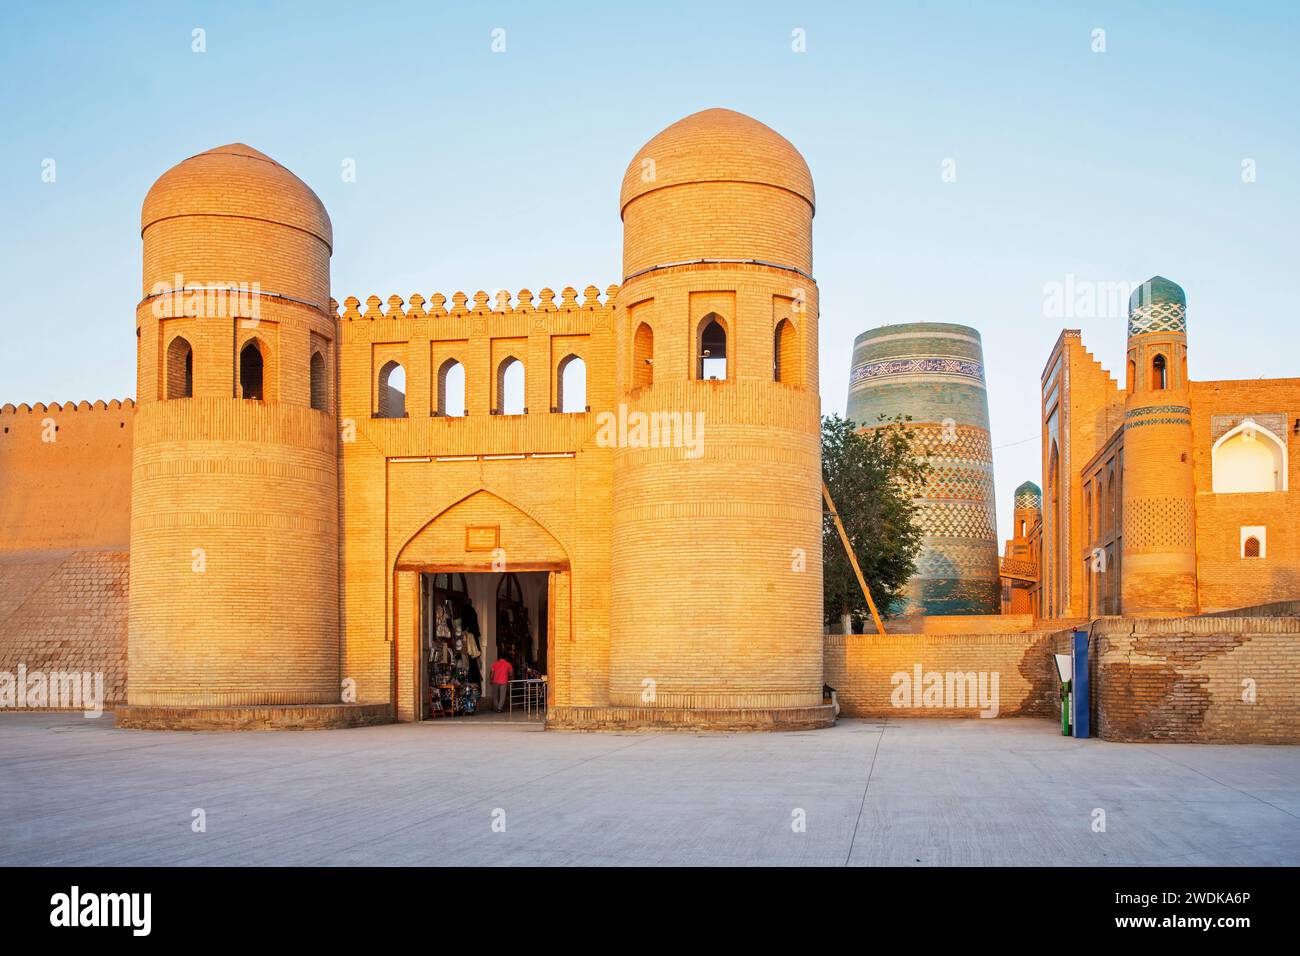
[0,550,129,705]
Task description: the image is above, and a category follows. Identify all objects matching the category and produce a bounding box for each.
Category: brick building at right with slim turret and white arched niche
[1030,276,1300,619]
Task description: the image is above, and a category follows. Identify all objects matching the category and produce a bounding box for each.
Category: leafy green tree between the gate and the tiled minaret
[822,415,930,627]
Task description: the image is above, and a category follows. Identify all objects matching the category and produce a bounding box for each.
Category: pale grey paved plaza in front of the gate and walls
[0,713,1300,866]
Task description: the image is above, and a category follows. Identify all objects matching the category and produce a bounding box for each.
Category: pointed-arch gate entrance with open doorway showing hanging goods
[393,490,572,721]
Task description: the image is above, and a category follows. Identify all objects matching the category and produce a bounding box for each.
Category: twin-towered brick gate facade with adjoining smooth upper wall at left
[0,109,831,728]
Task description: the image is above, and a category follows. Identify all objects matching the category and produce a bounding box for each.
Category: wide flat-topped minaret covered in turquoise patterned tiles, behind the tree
[848,323,1000,614]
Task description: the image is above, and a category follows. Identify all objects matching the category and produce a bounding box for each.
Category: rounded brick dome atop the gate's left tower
[140,143,334,250]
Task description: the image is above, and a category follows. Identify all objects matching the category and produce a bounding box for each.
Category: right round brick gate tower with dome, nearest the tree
[610,109,828,726]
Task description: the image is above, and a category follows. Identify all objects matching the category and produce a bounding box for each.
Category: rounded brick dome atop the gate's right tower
[619,109,816,213]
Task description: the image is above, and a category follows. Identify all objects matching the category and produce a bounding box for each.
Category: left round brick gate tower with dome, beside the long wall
[127,144,339,708]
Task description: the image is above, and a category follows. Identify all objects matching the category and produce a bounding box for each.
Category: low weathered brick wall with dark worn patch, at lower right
[1092,618,1300,744]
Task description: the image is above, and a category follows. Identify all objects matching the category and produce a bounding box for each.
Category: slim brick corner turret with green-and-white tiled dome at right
[1119,276,1196,615]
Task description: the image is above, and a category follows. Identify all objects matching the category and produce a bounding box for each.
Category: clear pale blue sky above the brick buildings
[0,0,1300,546]
